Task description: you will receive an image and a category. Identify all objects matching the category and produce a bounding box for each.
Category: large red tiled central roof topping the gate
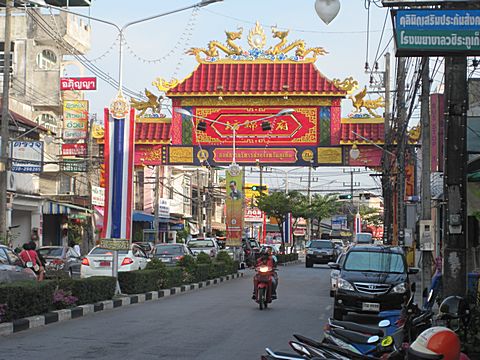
[167,62,346,97]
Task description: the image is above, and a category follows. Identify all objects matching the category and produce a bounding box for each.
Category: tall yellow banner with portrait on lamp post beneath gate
[226,169,244,246]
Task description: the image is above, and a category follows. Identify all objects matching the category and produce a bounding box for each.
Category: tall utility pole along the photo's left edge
[0,0,13,243]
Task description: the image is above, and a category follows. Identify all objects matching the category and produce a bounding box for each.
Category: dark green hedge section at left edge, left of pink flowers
[0,280,56,321]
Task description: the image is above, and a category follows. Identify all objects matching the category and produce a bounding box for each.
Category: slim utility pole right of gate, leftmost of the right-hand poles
[382,52,392,244]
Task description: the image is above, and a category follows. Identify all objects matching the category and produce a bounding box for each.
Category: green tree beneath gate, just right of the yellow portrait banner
[257,191,305,249]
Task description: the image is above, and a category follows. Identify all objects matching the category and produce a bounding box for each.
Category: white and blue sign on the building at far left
[10,141,43,173]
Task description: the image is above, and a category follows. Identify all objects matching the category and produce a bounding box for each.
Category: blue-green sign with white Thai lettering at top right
[393,9,480,56]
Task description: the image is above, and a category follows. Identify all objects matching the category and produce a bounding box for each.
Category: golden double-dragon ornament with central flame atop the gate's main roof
[187,21,328,64]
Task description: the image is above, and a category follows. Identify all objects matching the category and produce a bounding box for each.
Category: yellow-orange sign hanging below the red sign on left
[63,100,88,140]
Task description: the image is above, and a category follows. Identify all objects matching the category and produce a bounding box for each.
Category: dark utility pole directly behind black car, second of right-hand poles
[393,57,407,246]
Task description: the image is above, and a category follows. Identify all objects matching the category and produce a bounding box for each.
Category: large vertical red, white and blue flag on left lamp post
[102,109,135,239]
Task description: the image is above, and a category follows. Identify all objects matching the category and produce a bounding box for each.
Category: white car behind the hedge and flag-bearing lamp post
[80,244,150,278]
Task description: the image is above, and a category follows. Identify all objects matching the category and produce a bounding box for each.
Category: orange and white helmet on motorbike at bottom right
[410,326,460,360]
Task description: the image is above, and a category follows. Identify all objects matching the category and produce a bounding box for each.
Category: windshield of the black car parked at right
[343,251,405,274]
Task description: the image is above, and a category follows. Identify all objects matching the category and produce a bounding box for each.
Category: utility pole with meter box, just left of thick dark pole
[420,57,432,304]
